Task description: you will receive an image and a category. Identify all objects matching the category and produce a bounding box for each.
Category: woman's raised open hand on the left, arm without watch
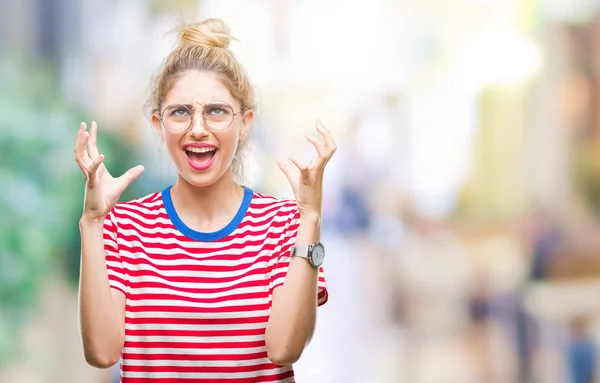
[75,122,144,221]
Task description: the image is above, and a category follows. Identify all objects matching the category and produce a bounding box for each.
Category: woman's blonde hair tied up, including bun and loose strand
[147,18,256,183]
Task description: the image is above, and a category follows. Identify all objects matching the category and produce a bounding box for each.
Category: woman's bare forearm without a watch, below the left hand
[79,219,125,368]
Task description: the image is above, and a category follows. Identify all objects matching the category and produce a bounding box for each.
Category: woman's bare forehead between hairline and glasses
[165,70,236,105]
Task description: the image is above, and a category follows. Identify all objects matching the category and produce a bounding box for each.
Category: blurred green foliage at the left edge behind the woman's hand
[0,59,144,369]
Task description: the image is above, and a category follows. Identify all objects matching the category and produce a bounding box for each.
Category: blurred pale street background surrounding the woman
[5,0,600,383]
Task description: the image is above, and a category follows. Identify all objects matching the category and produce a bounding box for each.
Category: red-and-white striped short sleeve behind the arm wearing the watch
[270,208,329,306]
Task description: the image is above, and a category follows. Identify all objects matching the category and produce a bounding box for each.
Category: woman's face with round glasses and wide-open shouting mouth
[152,71,253,187]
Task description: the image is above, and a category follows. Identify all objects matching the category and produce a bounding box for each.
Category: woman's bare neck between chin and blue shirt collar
[171,170,244,229]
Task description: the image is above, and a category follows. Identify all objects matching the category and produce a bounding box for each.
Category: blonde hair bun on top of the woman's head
[179,19,233,48]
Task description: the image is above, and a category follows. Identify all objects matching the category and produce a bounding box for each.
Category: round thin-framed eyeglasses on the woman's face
[160,101,244,133]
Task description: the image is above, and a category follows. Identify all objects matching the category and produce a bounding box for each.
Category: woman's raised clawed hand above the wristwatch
[277,119,337,218]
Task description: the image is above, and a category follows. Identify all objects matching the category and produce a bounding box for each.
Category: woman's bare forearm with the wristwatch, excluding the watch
[266,213,320,365]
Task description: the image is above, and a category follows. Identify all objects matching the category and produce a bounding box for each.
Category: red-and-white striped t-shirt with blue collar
[104,188,327,383]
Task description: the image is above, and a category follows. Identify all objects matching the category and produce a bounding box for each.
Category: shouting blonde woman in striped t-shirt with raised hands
[75,19,336,383]
